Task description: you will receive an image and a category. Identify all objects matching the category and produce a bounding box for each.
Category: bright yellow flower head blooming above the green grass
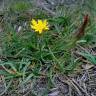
[31,19,49,34]
